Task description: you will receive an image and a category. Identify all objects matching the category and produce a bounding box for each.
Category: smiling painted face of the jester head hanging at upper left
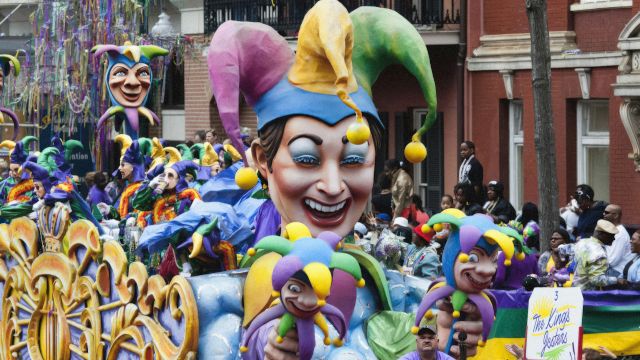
[109,63,151,108]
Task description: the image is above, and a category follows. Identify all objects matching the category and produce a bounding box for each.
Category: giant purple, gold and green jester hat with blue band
[208,0,436,186]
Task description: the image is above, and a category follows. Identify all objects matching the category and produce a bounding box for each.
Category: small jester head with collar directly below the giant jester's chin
[240,223,364,360]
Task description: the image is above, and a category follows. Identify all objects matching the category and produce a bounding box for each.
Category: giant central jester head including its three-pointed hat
[208,0,437,236]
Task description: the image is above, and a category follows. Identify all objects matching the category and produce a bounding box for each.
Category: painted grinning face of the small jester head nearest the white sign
[453,247,498,294]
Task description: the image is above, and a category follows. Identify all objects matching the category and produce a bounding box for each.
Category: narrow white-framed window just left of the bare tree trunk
[509,100,524,210]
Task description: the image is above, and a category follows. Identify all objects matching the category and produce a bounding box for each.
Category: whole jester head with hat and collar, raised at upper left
[91,41,169,138]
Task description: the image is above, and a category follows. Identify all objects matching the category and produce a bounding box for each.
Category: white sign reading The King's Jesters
[525,288,583,360]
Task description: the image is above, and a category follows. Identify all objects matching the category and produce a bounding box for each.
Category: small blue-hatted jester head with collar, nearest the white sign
[411,209,525,351]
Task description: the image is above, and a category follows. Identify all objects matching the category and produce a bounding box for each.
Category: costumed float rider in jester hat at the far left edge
[0,136,38,204]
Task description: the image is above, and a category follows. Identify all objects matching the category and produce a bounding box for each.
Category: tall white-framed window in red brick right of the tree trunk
[577,100,609,201]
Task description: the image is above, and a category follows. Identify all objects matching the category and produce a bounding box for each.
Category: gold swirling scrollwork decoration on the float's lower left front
[0,215,198,360]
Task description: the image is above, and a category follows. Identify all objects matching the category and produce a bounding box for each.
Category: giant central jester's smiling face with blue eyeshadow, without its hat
[254,116,375,236]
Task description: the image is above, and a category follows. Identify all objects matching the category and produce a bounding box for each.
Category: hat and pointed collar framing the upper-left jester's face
[91,41,169,133]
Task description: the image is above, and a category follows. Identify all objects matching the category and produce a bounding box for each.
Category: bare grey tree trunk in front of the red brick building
[525,0,559,251]
